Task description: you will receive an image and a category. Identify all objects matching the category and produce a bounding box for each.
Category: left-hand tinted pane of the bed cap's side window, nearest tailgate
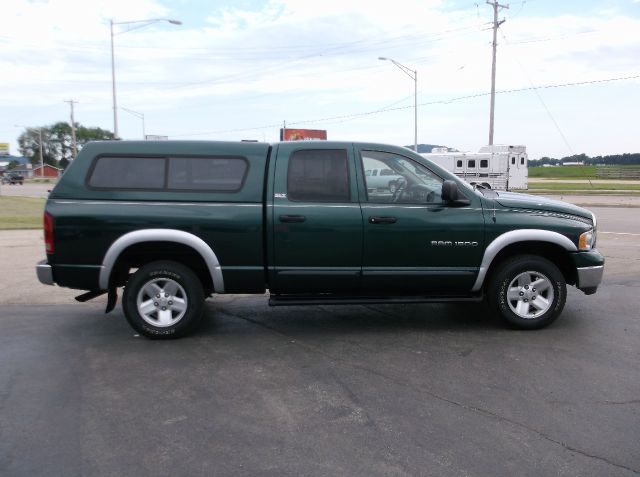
[89,157,166,189]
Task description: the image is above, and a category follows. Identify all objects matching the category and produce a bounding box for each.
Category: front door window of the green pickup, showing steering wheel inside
[361,151,443,204]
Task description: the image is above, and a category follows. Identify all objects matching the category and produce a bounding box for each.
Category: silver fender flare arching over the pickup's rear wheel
[98,229,224,293]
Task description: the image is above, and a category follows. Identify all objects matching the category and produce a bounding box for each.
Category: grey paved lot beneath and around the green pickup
[0,203,640,476]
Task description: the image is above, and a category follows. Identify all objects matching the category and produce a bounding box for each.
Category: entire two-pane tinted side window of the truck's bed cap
[88,156,248,192]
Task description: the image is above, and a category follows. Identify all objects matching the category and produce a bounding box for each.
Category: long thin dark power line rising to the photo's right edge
[169,74,640,138]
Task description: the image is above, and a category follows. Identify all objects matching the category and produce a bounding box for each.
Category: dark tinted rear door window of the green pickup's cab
[287,149,350,202]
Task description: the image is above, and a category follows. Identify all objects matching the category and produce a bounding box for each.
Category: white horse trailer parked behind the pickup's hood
[421,145,529,190]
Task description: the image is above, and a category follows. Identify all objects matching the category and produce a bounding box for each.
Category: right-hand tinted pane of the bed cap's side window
[168,157,247,191]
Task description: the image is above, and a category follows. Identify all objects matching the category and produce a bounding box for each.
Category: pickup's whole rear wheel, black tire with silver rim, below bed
[122,261,205,339]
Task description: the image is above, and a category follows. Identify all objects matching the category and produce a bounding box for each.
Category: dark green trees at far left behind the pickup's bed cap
[18,121,115,169]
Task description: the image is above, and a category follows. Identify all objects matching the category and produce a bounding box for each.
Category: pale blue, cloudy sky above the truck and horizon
[0,0,640,159]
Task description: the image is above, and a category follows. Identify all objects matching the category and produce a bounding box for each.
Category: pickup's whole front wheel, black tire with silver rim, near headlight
[487,255,567,330]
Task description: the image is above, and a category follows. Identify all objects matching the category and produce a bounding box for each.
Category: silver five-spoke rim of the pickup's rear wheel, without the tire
[136,278,188,328]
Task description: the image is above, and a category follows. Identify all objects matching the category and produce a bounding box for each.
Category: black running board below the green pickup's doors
[269,295,484,306]
